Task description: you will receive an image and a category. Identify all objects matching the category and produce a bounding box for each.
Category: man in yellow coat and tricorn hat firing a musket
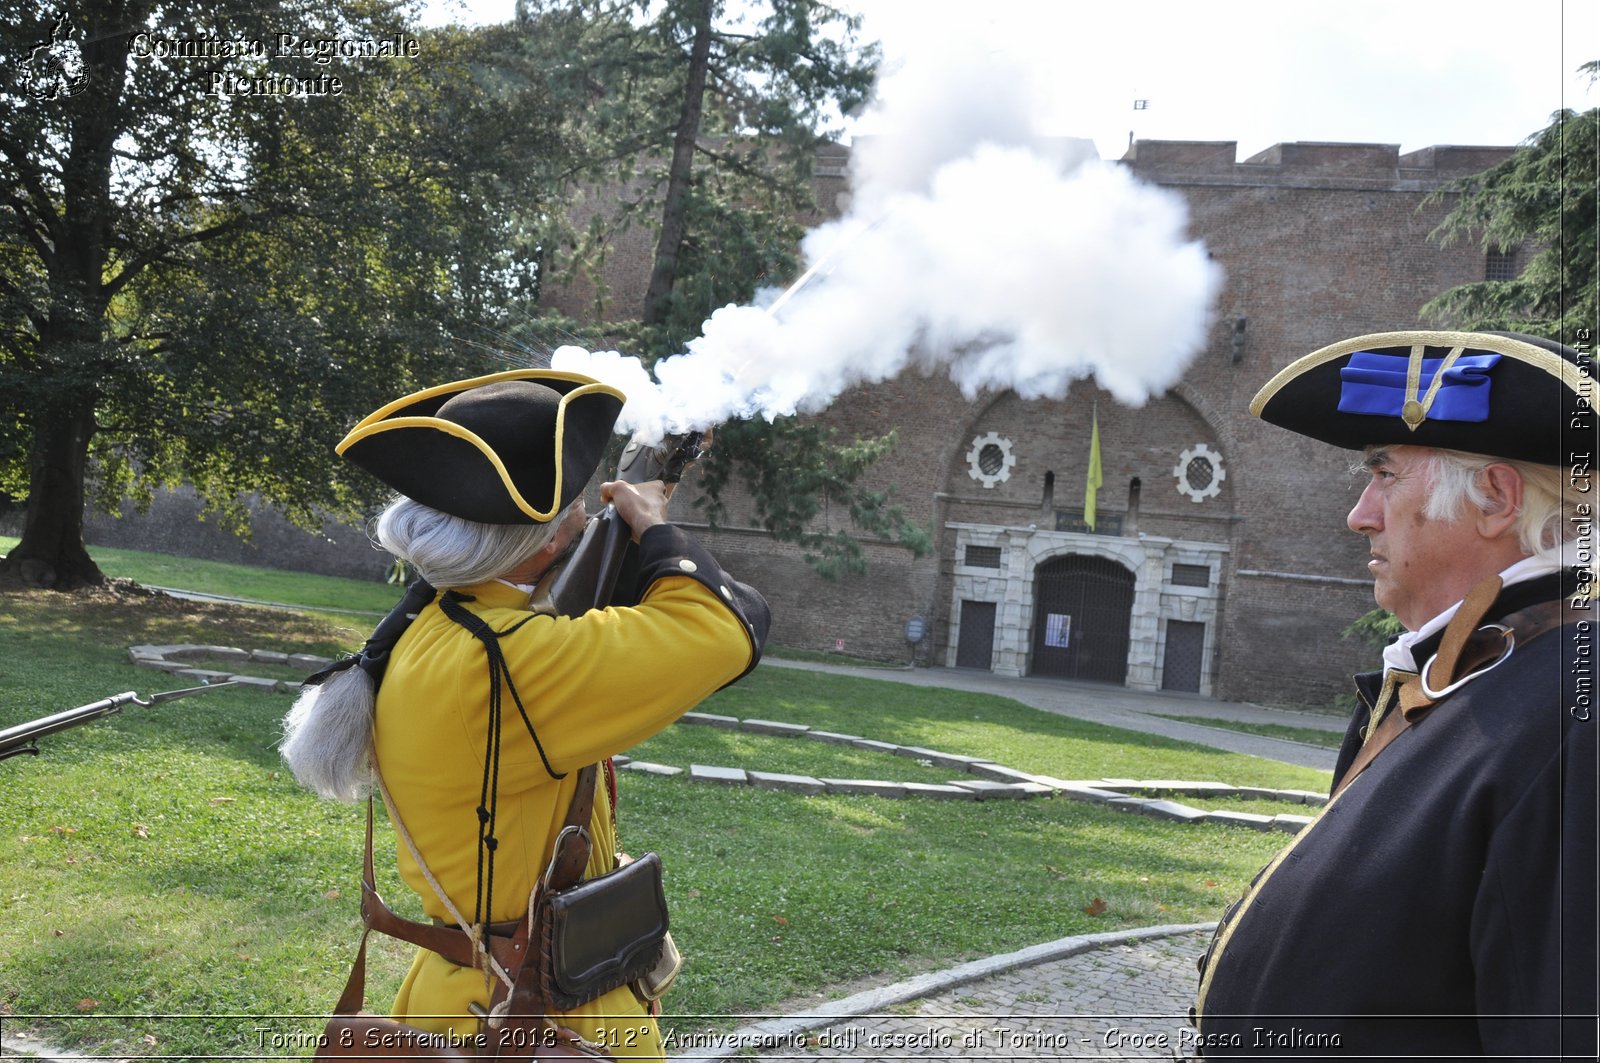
[283,370,770,1058]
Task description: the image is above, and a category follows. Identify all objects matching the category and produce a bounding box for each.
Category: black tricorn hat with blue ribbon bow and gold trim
[1250,331,1594,464]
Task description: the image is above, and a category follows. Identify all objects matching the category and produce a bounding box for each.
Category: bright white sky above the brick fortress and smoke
[427,0,1600,160]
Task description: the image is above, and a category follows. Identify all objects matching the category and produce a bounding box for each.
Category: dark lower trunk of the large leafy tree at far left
[5,397,106,591]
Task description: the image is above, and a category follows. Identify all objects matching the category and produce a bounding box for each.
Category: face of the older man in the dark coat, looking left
[1347,447,1499,631]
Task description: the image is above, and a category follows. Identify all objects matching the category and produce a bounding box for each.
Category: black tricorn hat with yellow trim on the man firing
[334,370,624,523]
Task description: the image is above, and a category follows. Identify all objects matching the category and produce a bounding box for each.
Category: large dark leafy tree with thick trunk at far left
[0,0,576,588]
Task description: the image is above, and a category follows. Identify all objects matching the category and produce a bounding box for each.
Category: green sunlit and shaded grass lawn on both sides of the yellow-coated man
[0,551,1328,1055]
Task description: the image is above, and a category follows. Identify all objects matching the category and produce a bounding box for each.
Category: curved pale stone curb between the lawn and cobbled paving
[669,922,1216,1063]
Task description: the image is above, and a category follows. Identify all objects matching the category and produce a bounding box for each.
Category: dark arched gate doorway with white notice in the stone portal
[1032,556,1133,684]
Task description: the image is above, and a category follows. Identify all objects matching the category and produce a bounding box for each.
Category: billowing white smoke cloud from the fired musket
[552,32,1222,439]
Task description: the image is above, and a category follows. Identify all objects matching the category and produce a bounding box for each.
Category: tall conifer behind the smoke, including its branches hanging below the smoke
[509,0,931,576]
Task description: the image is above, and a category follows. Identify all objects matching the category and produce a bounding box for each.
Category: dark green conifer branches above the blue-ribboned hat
[1422,61,1600,343]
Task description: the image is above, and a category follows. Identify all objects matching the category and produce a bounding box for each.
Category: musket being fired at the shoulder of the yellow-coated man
[528,429,712,616]
